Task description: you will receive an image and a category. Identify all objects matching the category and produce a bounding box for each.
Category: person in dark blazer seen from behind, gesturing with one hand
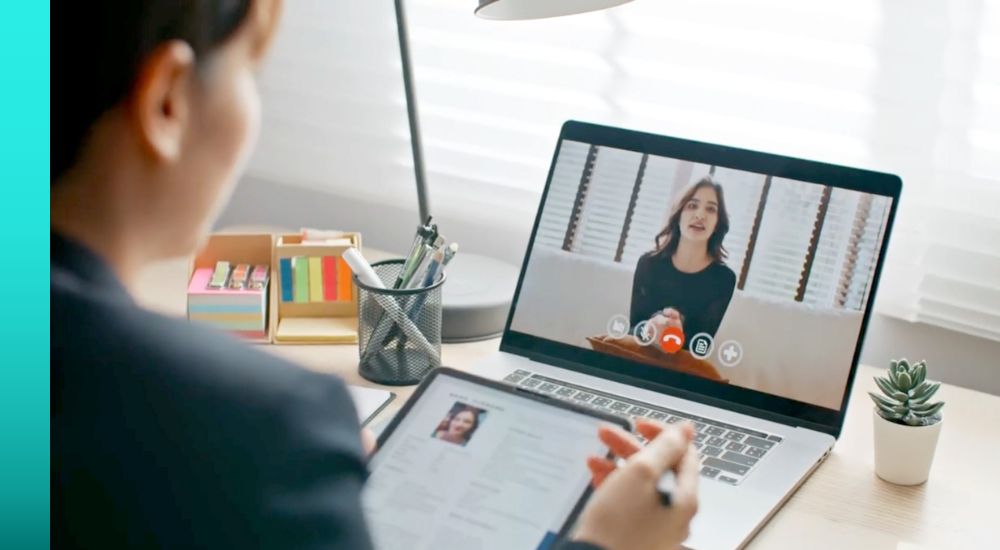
[50,0,698,550]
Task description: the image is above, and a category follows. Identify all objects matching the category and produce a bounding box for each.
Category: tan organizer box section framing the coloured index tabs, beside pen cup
[270,233,361,344]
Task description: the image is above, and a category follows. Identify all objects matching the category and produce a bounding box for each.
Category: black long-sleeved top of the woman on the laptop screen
[630,252,736,349]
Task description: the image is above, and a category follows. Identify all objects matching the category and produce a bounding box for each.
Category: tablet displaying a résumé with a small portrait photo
[362,368,629,550]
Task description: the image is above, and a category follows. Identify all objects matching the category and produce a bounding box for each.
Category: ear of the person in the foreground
[129,40,195,162]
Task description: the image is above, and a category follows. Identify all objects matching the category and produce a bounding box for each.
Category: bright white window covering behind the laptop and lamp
[250,0,1000,340]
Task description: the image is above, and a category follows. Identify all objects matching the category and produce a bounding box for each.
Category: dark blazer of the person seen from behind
[50,234,371,550]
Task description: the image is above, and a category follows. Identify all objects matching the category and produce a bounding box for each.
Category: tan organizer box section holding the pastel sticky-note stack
[188,233,274,343]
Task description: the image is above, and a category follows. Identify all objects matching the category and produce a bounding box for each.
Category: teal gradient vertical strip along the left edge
[0,2,50,549]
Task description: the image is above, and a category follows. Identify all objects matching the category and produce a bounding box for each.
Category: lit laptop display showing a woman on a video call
[510,139,892,410]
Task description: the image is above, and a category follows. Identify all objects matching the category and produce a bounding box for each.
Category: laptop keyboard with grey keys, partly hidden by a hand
[503,369,781,485]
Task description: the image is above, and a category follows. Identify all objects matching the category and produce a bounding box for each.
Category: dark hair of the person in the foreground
[50,0,254,184]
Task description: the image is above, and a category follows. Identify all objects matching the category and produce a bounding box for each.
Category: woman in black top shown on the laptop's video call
[630,176,736,349]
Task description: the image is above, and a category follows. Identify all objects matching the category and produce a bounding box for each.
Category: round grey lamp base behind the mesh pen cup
[441,252,520,343]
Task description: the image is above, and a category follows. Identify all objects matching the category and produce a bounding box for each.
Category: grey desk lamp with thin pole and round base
[395,0,630,342]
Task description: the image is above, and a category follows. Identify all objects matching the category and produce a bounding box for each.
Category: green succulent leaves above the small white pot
[868,359,944,426]
